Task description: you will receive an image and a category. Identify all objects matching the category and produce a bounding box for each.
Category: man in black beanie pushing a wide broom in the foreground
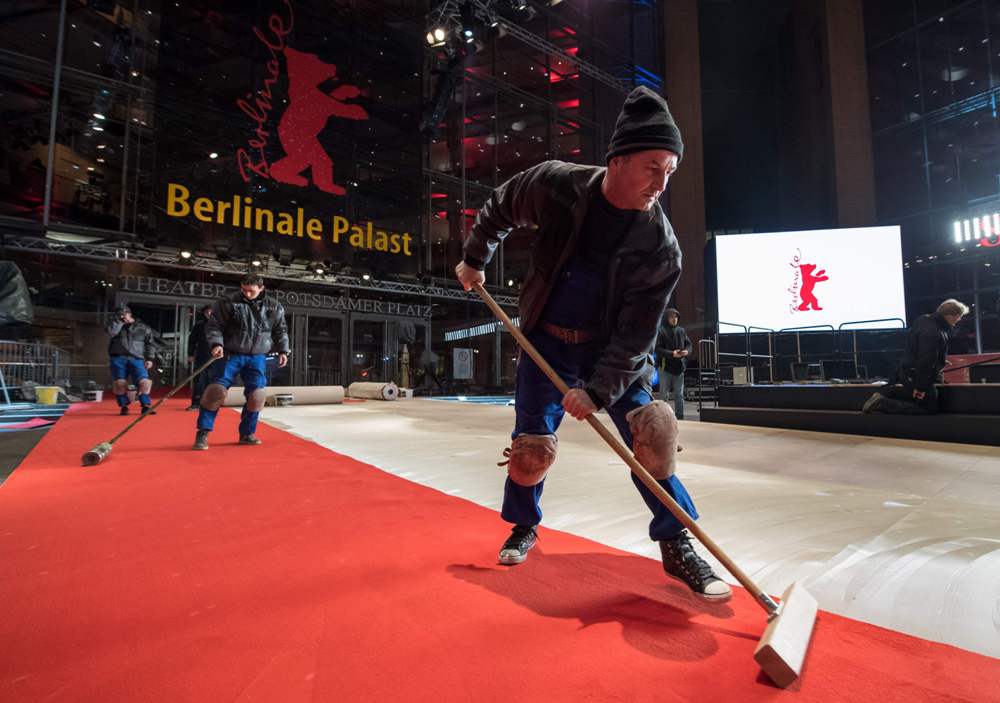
[455,87,731,601]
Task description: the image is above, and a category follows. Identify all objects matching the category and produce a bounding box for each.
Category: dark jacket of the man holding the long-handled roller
[205,291,289,354]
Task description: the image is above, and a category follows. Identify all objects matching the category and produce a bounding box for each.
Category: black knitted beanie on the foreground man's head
[606,85,684,161]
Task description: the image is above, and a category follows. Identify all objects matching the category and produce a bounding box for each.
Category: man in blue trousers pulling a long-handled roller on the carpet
[193,273,290,449]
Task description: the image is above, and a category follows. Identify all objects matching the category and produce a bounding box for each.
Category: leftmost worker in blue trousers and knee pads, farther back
[107,305,156,415]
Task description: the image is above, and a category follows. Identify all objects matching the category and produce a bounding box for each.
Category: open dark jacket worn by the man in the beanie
[465,161,681,406]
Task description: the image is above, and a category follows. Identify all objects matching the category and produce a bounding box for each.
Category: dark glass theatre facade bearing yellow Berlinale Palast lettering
[0,0,662,391]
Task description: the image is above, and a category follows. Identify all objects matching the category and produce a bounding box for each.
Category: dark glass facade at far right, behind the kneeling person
[865,0,1000,353]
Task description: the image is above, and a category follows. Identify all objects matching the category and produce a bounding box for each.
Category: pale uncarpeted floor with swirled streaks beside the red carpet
[264,400,1000,657]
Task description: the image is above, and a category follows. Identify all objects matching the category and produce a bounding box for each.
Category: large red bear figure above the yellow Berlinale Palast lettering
[270,47,368,195]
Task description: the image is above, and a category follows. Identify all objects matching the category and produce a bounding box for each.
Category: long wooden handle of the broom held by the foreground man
[473,283,778,615]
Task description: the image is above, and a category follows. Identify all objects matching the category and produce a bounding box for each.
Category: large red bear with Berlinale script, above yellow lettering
[236,0,368,195]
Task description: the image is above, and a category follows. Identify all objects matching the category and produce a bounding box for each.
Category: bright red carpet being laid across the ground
[0,401,1000,703]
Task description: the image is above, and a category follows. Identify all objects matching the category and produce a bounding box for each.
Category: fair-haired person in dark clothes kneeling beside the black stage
[862,300,969,415]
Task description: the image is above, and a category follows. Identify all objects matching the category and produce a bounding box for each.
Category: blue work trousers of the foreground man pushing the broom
[500,331,698,540]
